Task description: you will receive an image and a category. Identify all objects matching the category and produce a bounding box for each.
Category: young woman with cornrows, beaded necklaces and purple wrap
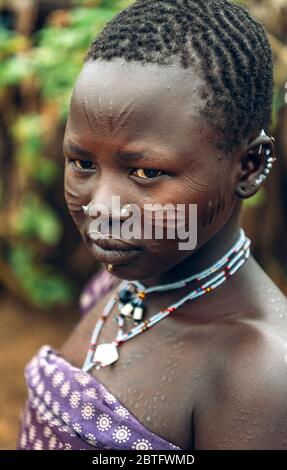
[18,0,287,449]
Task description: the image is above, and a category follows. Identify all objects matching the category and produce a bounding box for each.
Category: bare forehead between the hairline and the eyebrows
[67,59,216,156]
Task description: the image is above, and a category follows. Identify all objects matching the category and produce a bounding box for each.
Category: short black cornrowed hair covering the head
[84,0,274,153]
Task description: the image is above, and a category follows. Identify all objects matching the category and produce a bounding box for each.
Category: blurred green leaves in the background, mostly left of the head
[0,0,284,308]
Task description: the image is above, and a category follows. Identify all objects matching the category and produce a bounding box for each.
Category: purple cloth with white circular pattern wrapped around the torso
[17,271,181,450]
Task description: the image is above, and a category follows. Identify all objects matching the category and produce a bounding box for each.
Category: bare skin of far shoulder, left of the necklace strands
[57,287,116,367]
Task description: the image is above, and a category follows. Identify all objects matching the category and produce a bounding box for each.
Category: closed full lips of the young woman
[89,236,142,265]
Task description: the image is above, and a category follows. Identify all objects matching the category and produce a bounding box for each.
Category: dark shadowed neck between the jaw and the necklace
[142,205,244,287]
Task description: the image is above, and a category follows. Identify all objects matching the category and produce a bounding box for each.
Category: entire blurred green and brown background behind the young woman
[0,0,287,449]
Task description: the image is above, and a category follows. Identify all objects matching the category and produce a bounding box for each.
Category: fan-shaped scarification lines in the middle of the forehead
[84,97,137,137]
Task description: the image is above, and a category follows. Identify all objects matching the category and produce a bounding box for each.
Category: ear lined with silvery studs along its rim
[235,130,276,199]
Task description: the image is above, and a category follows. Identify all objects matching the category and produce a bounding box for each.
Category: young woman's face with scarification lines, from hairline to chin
[63,59,243,280]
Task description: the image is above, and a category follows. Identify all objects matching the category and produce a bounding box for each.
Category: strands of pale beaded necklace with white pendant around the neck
[82,228,251,372]
